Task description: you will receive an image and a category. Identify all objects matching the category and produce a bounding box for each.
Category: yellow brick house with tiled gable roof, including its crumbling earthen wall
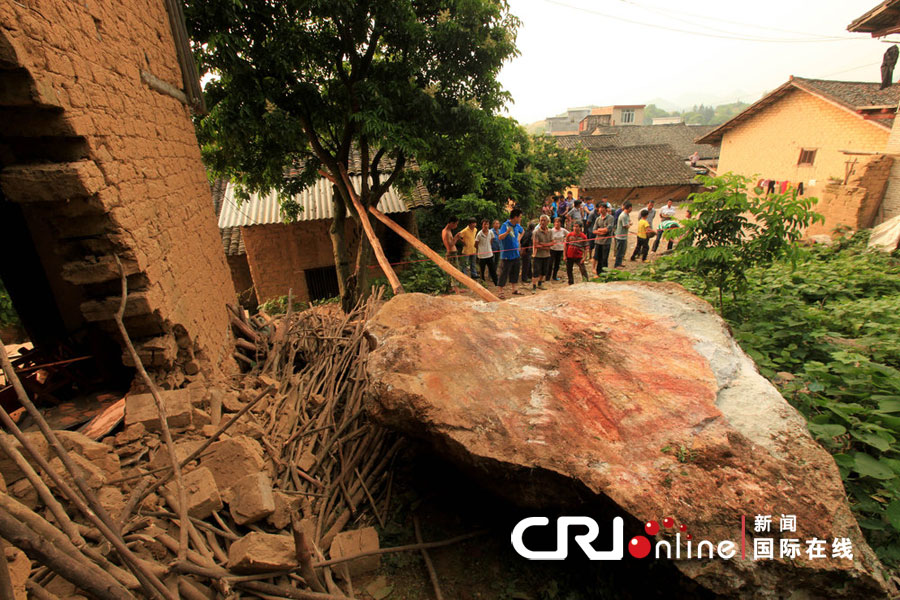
[697,77,900,235]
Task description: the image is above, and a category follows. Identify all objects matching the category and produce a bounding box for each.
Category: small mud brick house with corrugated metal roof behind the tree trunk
[219,175,431,303]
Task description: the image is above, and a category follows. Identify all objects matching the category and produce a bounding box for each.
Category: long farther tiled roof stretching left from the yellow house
[556,123,719,159]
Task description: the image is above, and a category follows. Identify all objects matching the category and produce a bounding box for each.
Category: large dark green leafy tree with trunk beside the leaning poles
[185,0,519,307]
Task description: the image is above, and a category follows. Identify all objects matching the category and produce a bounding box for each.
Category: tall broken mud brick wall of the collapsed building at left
[0,0,235,378]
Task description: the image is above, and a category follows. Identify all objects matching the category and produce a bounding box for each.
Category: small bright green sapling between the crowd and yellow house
[665,173,822,311]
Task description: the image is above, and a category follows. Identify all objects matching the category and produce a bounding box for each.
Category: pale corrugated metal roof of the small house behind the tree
[219,176,431,228]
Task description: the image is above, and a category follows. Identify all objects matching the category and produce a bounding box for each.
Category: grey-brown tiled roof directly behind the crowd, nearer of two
[578,144,695,188]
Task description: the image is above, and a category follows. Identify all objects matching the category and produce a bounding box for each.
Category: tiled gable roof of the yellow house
[697,77,900,144]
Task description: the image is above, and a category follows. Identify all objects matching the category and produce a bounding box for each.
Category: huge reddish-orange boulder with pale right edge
[368,283,886,598]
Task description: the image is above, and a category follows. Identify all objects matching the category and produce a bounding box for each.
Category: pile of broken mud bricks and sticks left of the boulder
[0,297,401,600]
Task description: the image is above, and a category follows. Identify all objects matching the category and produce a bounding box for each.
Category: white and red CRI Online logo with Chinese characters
[511,515,853,560]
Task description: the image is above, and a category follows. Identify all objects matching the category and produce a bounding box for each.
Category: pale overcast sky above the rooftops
[500,0,900,124]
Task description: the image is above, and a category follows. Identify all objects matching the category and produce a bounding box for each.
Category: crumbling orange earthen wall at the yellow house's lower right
[806,154,894,236]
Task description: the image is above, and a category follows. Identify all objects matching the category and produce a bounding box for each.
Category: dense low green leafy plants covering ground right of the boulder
[636,232,900,567]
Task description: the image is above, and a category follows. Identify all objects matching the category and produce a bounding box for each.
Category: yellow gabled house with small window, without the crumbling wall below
[696,77,900,187]
